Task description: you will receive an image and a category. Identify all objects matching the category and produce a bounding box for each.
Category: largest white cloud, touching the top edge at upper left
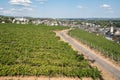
[9,0,32,6]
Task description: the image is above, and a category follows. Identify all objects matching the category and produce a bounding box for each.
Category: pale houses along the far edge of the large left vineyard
[0,17,61,26]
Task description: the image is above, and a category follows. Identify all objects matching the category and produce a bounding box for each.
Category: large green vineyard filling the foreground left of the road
[0,24,100,79]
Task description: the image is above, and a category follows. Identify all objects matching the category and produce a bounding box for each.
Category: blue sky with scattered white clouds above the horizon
[0,0,120,18]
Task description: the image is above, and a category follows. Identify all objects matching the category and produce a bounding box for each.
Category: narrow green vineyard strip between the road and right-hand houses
[69,29,120,62]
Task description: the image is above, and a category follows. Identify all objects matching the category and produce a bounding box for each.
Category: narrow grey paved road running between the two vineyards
[57,31,120,80]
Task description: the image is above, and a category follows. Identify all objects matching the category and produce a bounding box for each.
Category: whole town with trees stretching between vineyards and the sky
[0,16,120,43]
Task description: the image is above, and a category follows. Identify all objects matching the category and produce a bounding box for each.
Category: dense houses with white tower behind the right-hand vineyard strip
[71,22,120,43]
